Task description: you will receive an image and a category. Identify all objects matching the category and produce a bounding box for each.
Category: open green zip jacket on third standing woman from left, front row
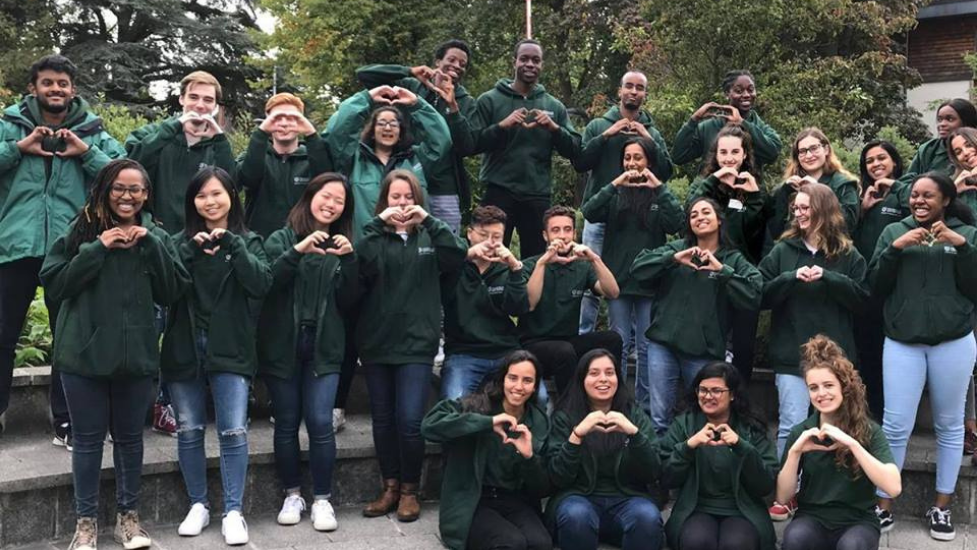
[258,227,359,379]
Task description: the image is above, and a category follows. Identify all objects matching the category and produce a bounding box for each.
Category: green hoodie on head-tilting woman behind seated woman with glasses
[631,239,763,359]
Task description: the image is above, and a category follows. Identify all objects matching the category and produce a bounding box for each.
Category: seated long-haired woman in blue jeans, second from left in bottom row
[546,349,662,550]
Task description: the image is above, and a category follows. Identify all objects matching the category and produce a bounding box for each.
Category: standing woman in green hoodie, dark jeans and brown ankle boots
[356,170,468,522]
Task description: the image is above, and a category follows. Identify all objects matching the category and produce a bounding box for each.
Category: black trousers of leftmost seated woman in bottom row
[467,494,553,550]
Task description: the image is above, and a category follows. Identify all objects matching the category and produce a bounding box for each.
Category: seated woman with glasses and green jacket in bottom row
[658,361,777,550]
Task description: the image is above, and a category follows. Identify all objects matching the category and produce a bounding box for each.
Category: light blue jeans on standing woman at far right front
[878,334,977,498]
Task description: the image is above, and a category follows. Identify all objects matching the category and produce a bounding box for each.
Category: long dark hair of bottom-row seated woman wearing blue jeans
[556,348,634,456]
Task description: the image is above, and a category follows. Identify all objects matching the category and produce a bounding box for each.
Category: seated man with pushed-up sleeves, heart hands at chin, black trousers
[519,206,621,402]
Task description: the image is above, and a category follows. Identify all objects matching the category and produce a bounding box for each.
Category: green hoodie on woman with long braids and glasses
[40,212,190,378]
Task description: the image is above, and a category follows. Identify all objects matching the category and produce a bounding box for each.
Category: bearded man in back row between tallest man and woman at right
[573,71,672,334]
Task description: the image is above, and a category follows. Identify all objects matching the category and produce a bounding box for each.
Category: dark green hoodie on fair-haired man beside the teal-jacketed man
[125,116,236,235]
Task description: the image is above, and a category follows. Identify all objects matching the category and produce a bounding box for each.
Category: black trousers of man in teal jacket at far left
[0,258,69,426]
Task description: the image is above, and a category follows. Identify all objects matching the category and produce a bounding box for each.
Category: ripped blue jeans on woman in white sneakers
[167,334,250,514]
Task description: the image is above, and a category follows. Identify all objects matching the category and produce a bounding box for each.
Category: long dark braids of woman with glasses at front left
[66,159,151,256]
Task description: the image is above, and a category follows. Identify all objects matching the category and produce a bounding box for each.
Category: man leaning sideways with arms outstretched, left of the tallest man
[356,39,475,233]
